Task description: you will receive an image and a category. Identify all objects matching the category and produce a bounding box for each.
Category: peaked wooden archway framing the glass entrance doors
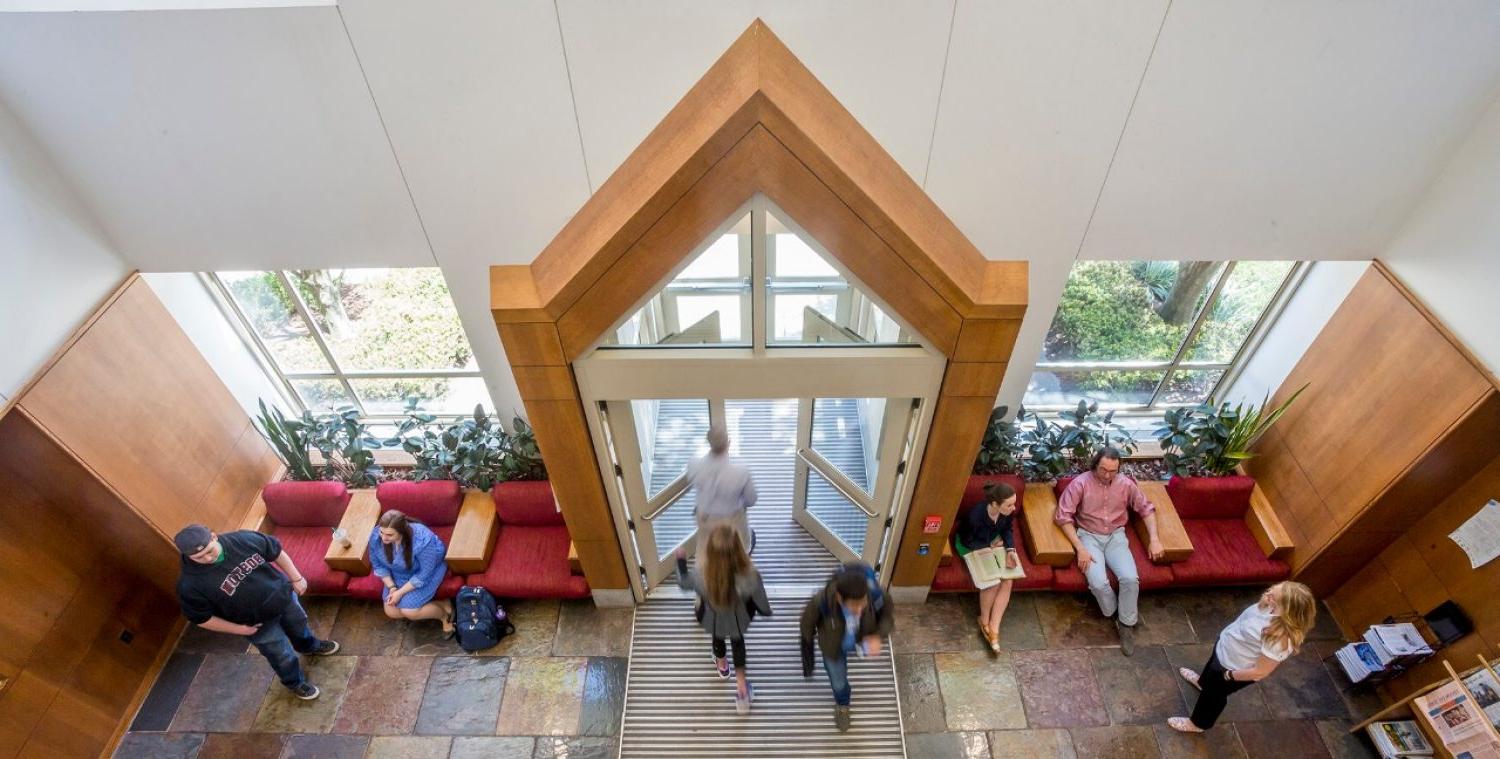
[491,20,1026,590]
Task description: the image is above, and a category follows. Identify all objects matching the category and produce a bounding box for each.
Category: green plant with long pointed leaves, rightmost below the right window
[1157,386,1307,477]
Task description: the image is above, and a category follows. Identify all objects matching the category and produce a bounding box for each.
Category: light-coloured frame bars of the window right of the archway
[1025,261,1308,417]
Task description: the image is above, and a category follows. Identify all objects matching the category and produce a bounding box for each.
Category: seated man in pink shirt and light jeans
[1053,447,1161,656]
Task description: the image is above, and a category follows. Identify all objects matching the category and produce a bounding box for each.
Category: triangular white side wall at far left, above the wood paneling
[0,96,131,398]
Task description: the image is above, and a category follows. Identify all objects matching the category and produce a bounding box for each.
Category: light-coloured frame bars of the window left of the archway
[198,267,495,422]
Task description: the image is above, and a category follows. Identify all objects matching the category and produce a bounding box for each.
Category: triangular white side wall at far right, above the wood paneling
[1380,98,1500,379]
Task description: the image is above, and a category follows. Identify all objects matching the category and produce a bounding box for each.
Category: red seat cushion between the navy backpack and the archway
[468,525,588,599]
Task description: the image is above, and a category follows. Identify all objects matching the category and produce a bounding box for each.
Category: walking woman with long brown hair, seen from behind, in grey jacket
[677,522,771,714]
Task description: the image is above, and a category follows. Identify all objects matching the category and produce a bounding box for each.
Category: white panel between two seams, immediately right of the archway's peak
[927,0,1167,267]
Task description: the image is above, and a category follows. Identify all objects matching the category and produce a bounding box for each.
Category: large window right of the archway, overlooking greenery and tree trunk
[1025,261,1299,414]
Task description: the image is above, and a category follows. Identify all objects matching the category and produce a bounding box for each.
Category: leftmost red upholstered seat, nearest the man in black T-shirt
[261,482,350,596]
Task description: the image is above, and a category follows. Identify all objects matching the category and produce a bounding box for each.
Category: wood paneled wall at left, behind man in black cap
[0,276,279,758]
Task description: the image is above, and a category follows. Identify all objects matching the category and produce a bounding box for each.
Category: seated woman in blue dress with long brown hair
[371,509,453,638]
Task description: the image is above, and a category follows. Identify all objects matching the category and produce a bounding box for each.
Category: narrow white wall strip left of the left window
[141,273,291,416]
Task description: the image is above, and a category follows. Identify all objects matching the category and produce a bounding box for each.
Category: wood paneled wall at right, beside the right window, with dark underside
[1247,264,1500,597]
